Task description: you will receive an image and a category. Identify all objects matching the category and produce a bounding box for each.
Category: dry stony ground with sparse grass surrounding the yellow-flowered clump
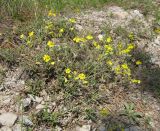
[0,1,160,131]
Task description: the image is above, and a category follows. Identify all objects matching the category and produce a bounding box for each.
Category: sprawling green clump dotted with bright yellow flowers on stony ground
[0,10,143,126]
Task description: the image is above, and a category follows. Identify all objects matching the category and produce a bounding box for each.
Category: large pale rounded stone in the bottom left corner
[0,112,17,127]
